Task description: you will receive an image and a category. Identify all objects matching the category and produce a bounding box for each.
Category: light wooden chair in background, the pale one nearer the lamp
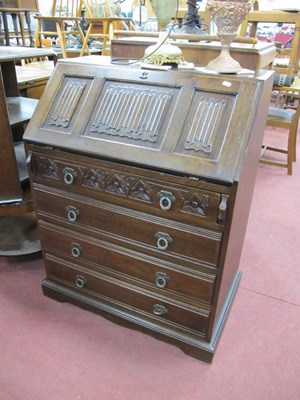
[80,0,132,56]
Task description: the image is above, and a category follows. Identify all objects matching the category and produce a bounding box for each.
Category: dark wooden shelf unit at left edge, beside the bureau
[0,47,55,216]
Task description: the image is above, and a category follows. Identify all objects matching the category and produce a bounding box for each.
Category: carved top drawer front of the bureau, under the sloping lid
[32,153,228,225]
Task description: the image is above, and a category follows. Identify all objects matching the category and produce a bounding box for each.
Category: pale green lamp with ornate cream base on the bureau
[145,0,182,65]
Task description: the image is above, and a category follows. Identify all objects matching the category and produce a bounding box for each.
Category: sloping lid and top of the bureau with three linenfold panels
[24,56,272,183]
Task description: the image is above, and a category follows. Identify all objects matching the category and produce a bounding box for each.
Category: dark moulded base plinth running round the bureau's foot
[42,271,241,363]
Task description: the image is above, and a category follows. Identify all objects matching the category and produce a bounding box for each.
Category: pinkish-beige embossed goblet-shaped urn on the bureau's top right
[206,0,254,73]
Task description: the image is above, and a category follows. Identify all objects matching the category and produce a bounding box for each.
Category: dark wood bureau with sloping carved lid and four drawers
[24,56,273,362]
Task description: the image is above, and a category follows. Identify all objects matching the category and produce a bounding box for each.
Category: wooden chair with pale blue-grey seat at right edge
[260,100,300,175]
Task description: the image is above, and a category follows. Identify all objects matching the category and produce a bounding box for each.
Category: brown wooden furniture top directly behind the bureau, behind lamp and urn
[111,37,276,70]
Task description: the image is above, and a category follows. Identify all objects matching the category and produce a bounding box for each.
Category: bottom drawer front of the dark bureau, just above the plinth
[45,254,209,335]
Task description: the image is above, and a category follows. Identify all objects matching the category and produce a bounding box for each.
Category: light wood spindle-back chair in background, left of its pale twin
[35,0,90,58]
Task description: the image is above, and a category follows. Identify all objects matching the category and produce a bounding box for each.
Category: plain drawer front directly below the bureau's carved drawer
[36,190,222,266]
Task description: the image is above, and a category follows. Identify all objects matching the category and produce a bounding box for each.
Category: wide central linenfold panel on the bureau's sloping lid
[90,84,172,142]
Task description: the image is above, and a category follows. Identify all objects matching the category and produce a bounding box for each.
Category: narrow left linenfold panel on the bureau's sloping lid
[49,79,86,128]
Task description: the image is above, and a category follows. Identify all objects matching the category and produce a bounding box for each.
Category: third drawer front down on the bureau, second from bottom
[39,221,215,304]
